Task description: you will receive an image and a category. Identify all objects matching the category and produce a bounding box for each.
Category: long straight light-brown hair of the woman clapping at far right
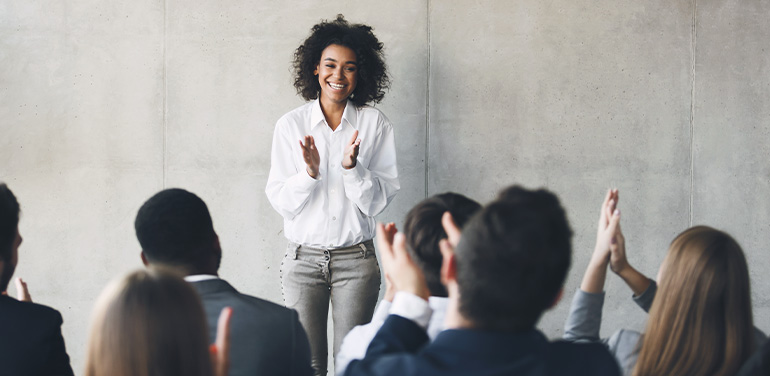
[634,226,754,375]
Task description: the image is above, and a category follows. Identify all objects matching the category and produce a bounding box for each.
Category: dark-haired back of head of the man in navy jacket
[455,187,572,332]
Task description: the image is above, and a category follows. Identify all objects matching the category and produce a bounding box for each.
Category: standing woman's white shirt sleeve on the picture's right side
[340,116,401,217]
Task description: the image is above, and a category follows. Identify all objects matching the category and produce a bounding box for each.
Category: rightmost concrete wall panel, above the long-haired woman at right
[693,1,770,330]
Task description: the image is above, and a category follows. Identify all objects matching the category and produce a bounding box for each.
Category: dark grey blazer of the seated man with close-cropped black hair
[192,279,313,376]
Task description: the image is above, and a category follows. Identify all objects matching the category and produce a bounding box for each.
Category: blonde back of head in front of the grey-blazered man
[85,269,212,376]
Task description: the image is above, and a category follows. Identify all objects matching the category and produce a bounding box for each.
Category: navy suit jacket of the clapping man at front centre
[345,315,620,376]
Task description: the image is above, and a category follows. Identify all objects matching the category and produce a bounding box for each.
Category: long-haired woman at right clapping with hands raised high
[564,190,764,376]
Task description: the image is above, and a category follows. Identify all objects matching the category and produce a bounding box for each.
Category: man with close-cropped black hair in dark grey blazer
[134,189,313,376]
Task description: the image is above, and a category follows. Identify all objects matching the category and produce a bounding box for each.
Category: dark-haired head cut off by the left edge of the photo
[0,183,19,291]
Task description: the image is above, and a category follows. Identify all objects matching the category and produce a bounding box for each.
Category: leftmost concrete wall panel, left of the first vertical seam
[0,1,163,374]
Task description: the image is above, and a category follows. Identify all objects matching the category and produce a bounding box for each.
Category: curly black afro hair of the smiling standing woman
[294,14,390,107]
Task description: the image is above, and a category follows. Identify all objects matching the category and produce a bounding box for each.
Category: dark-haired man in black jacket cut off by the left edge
[0,183,73,375]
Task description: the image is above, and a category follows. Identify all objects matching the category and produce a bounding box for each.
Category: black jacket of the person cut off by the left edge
[0,295,72,376]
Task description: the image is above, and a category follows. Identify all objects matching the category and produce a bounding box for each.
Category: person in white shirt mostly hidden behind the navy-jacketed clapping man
[334,192,481,375]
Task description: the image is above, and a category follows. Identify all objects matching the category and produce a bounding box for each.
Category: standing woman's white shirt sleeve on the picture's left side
[265,119,321,219]
